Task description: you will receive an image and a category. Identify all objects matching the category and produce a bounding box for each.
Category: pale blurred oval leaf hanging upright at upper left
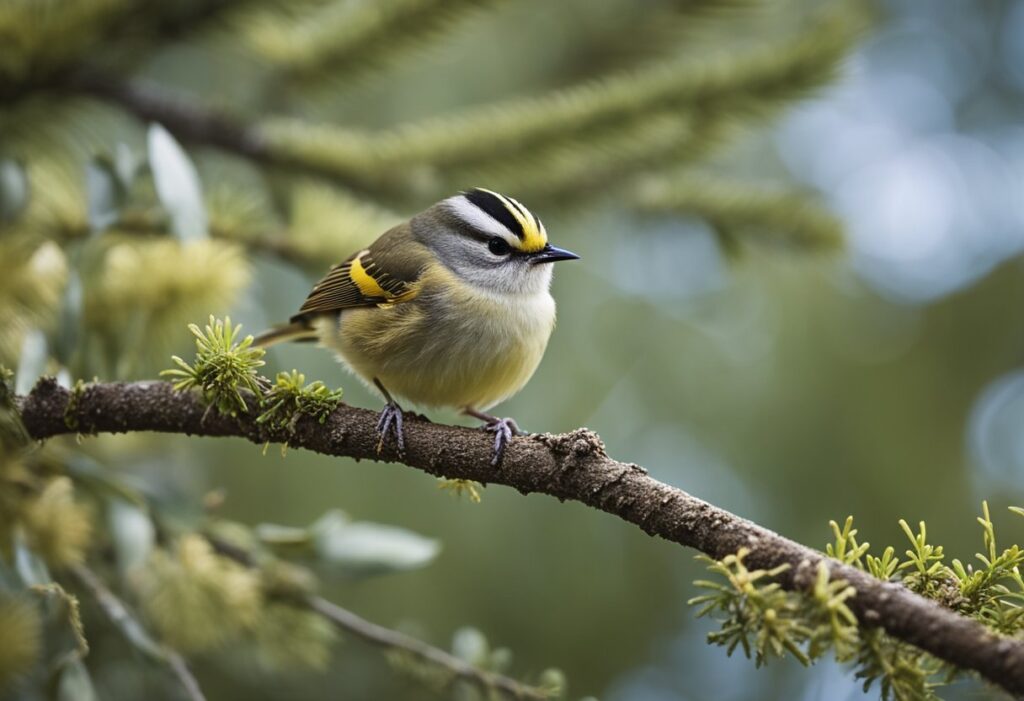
[147,124,209,242]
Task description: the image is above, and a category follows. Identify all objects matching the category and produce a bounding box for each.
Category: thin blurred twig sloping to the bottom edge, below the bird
[305,597,550,701]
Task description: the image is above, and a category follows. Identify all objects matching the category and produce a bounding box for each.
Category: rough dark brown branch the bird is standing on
[17,379,1024,695]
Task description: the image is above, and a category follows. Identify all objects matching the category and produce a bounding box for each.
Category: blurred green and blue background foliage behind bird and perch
[0,0,1024,701]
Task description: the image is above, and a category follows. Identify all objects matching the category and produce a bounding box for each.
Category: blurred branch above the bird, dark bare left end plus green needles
[61,0,866,196]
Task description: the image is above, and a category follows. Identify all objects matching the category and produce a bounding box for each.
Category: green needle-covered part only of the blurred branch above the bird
[259,2,866,187]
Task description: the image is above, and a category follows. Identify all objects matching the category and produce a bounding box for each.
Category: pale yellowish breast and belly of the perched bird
[325,294,555,410]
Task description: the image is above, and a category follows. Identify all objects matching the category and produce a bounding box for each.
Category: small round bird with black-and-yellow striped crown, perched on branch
[256,188,579,465]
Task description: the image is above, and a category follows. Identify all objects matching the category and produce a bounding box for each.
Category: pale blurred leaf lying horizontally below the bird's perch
[310,512,440,575]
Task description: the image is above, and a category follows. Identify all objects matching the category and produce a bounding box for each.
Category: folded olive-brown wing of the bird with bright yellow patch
[293,223,428,318]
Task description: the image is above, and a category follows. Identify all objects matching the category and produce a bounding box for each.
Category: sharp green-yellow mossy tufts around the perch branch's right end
[689,502,1024,701]
